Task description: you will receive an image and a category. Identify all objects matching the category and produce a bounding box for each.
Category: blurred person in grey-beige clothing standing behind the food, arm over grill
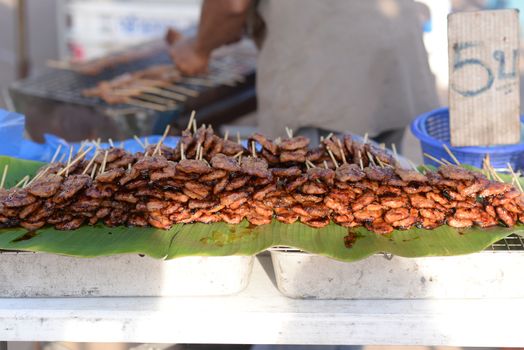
[171,0,439,146]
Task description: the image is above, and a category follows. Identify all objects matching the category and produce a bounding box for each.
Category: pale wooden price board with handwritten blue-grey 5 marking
[448,10,520,146]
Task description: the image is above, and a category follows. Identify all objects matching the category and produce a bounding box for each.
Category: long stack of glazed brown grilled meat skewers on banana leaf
[0,126,524,234]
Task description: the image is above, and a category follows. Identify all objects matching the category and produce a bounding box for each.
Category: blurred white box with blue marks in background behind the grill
[64,0,201,59]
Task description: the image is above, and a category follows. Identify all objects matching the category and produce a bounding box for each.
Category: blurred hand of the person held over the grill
[171,38,210,75]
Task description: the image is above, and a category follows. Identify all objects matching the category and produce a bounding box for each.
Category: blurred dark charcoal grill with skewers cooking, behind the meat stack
[9,41,256,142]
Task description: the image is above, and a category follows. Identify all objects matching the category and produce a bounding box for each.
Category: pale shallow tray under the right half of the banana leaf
[271,250,524,299]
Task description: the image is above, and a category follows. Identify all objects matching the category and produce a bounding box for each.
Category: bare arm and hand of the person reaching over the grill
[171,0,252,75]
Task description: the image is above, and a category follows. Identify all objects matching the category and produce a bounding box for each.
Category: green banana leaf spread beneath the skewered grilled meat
[0,157,524,261]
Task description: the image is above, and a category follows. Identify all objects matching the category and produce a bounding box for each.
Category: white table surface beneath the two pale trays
[0,257,524,347]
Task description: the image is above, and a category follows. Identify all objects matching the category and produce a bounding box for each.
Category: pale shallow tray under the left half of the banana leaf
[0,252,254,297]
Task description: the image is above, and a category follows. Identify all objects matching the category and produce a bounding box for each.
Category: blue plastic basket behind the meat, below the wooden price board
[411,108,524,170]
